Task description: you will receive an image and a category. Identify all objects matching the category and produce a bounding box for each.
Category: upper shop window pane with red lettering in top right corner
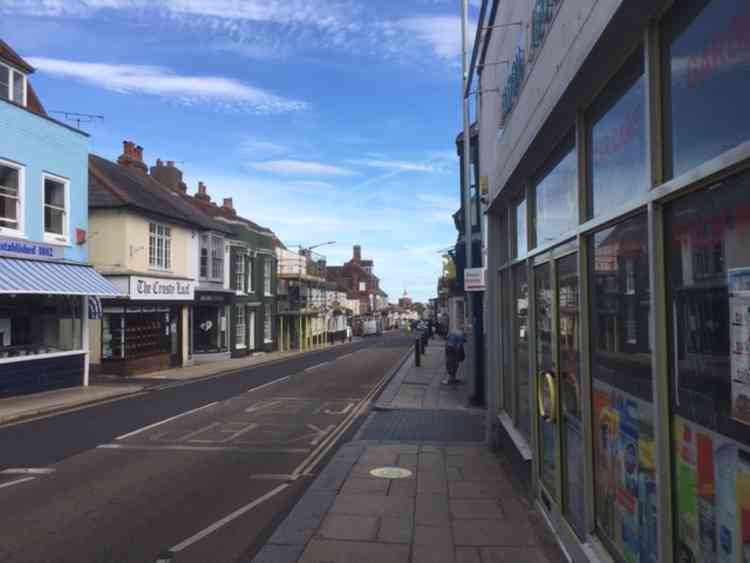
[662,0,750,176]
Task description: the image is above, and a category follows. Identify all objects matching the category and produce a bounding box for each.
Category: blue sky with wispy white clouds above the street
[0,0,479,301]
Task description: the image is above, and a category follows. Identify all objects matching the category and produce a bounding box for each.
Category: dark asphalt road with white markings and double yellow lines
[0,335,411,563]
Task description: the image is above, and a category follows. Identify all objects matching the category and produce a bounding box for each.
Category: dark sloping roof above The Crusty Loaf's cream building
[89,154,230,233]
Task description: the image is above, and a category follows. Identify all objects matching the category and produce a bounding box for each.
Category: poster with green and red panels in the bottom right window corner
[674,418,750,563]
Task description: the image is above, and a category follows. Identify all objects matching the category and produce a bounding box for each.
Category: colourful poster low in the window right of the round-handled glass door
[594,381,657,563]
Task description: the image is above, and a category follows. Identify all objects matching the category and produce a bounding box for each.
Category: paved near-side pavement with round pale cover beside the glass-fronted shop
[251,340,566,563]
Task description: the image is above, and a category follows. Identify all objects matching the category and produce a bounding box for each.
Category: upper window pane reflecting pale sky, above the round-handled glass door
[534,142,578,246]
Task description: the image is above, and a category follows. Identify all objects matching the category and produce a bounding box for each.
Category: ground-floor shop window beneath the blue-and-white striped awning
[0,295,82,358]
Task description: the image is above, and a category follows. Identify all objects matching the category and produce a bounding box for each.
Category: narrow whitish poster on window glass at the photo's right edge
[728,268,750,424]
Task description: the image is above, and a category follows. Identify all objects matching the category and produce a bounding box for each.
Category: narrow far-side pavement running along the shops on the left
[0,338,361,425]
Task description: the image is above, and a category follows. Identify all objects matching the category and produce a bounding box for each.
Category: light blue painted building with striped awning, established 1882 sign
[0,40,119,397]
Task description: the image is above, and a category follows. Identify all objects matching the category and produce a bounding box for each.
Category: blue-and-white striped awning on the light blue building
[0,258,124,297]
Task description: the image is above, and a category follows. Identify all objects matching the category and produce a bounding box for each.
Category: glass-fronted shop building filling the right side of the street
[476,0,750,563]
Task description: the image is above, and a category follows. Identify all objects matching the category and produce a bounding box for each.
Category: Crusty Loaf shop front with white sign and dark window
[101,276,195,376]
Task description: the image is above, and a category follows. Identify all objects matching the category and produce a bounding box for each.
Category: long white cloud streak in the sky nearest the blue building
[27,57,307,113]
